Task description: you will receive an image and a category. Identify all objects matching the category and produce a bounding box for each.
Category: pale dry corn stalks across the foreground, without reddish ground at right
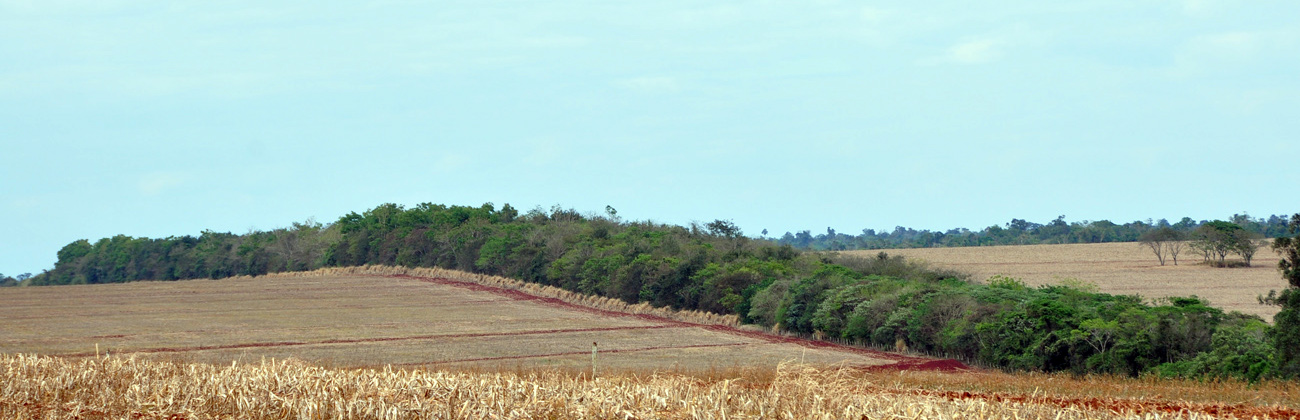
[0,355,1227,419]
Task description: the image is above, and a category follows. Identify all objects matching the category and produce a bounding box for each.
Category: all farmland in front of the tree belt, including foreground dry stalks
[0,268,1300,419]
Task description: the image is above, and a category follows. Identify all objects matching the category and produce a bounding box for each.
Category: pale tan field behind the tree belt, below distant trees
[845,242,1286,321]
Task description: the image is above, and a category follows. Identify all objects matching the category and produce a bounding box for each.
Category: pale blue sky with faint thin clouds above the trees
[0,0,1300,276]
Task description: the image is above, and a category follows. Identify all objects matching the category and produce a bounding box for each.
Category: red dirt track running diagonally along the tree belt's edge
[384,274,971,371]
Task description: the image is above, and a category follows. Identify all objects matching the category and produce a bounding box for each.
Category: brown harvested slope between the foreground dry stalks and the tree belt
[0,268,925,369]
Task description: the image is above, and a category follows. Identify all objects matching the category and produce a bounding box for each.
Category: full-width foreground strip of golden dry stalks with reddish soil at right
[0,356,1300,420]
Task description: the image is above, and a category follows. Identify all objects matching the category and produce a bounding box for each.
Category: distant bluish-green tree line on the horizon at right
[780,213,1287,251]
